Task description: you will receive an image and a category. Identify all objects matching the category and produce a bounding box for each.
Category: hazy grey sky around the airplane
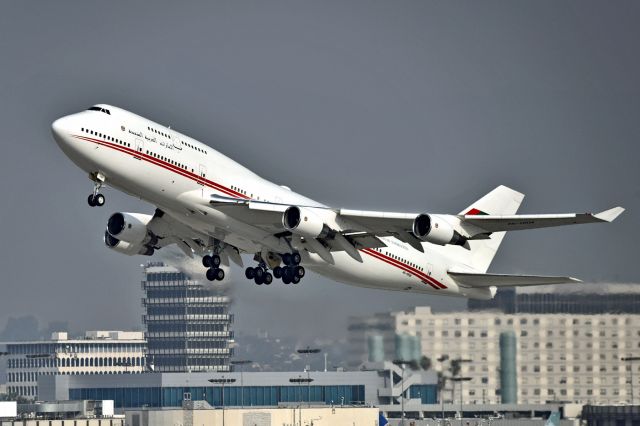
[0,1,640,336]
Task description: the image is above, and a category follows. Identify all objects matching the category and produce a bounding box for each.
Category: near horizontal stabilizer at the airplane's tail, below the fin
[449,271,582,287]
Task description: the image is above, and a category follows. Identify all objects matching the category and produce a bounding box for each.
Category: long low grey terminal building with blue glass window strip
[38,363,437,411]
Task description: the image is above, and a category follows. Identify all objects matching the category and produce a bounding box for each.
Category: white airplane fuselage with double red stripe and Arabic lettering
[53,105,480,298]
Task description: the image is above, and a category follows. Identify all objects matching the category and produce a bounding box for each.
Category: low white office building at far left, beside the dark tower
[0,331,146,398]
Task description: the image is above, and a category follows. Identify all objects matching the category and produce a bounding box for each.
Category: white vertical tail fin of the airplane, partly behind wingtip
[459,185,524,272]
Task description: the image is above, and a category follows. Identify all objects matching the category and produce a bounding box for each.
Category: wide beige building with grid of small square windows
[349,307,640,404]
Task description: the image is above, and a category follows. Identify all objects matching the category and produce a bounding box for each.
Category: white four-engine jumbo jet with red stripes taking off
[52,104,624,300]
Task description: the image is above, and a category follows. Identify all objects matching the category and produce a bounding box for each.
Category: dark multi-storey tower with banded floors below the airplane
[142,263,233,372]
